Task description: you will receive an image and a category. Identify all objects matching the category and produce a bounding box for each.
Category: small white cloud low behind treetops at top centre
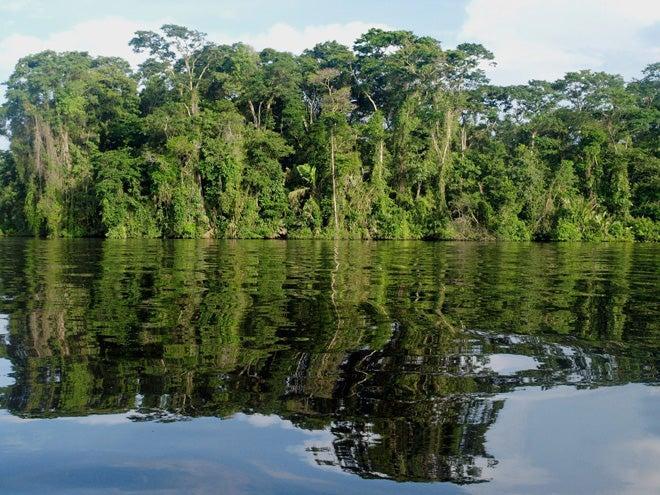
[212,21,391,53]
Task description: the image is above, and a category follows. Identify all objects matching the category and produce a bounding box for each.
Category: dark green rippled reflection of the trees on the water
[0,240,659,483]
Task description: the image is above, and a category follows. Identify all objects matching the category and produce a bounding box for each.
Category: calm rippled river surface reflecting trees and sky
[0,239,660,495]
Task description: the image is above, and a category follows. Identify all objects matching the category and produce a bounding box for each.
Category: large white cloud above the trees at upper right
[457,0,660,83]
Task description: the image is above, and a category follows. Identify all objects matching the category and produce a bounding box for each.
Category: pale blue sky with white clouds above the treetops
[0,0,660,84]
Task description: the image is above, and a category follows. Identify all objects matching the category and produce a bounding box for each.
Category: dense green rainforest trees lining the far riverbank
[0,25,660,240]
